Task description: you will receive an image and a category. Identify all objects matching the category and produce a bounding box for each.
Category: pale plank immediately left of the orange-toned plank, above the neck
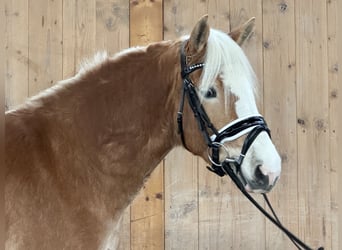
[96,0,129,54]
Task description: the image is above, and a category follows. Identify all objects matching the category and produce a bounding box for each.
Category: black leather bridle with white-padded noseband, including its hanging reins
[177,41,324,250]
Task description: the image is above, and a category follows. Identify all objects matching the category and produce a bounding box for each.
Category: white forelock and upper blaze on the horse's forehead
[199,29,258,116]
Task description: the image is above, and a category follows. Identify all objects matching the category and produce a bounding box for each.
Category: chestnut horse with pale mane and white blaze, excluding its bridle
[5,16,281,250]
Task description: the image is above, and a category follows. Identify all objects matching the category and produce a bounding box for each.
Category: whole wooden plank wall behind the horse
[4,0,342,250]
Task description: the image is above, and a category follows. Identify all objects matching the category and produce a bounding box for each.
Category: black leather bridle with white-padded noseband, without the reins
[177,41,270,178]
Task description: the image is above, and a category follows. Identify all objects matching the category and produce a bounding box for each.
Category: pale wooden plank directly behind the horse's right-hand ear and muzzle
[229,0,268,249]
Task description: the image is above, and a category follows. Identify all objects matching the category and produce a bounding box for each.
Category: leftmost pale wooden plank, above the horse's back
[4,0,28,109]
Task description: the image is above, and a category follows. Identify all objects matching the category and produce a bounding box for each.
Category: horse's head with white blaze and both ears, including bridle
[178,16,281,193]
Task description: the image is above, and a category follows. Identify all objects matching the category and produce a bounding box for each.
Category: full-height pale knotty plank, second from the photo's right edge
[295,0,331,249]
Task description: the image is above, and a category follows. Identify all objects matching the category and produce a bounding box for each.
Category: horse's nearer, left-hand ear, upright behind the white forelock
[189,15,210,54]
